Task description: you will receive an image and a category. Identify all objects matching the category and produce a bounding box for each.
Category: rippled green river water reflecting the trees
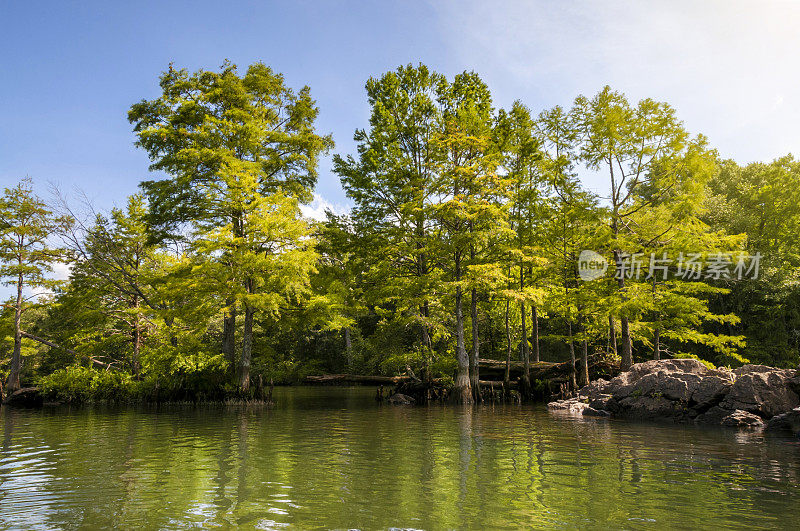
[0,387,800,529]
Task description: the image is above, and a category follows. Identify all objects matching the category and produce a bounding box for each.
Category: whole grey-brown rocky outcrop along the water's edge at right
[547,359,800,436]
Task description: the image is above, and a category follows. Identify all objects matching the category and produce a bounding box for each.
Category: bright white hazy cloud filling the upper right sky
[437,1,800,191]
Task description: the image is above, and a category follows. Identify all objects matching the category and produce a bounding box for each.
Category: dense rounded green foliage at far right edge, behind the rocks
[704,156,800,367]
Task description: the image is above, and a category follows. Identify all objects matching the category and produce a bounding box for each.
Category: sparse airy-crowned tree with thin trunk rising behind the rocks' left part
[571,87,711,369]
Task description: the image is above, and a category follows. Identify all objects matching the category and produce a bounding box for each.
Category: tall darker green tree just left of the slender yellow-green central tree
[334,65,445,382]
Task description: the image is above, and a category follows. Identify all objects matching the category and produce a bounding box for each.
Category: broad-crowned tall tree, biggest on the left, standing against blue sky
[128,63,332,392]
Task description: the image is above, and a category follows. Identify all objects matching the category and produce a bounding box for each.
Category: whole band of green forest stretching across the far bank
[0,63,800,402]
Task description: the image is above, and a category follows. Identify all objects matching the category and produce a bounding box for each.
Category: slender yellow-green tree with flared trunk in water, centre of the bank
[434,72,507,402]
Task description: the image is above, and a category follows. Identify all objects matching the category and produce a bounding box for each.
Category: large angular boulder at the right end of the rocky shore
[720,365,800,419]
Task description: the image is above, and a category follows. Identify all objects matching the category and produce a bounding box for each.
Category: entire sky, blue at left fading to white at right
[0,0,800,218]
